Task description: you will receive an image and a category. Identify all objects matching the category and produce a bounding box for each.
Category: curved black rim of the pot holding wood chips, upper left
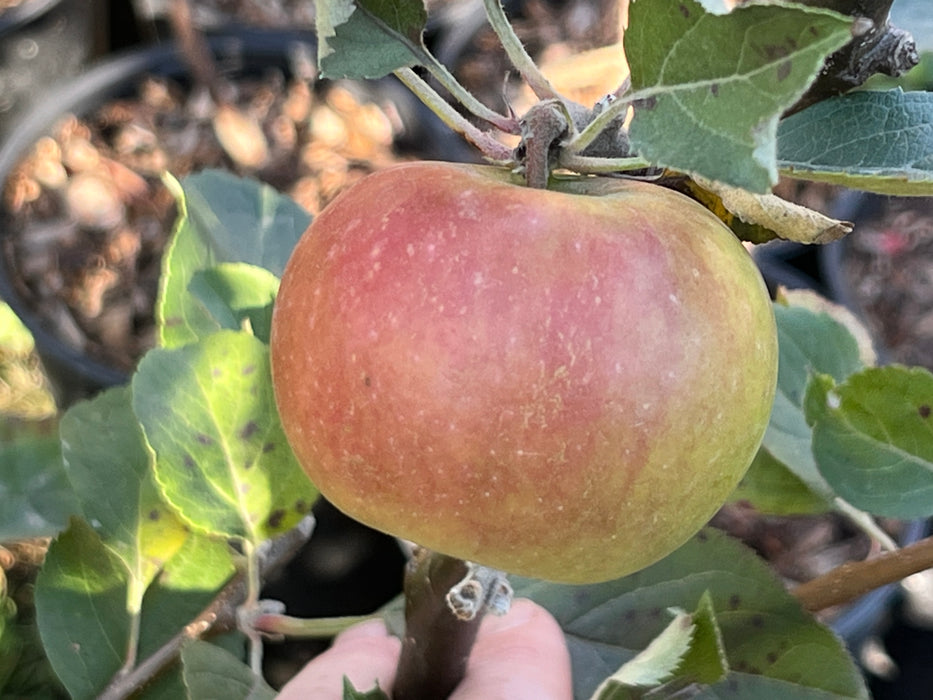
[0,30,334,405]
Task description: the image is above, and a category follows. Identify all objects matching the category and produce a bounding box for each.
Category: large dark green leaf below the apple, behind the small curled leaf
[512,530,867,699]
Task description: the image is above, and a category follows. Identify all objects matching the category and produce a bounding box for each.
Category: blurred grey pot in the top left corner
[0,0,102,138]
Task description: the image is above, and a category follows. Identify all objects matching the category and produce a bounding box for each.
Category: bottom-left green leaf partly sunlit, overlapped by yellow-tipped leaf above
[35,518,233,700]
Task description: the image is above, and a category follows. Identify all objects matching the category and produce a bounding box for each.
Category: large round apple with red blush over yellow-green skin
[271,162,777,583]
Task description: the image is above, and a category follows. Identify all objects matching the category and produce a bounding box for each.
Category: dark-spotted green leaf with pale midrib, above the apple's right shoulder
[625,0,852,192]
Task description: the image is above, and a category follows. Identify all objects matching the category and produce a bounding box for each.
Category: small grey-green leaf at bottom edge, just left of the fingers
[181,641,276,700]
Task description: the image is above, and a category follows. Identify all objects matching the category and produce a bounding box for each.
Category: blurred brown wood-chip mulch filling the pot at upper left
[3,63,401,370]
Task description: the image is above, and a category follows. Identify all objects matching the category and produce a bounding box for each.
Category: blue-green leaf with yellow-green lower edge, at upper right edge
[778,89,933,195]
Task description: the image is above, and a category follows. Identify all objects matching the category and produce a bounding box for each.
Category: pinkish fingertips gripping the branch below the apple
[279,600,573,700]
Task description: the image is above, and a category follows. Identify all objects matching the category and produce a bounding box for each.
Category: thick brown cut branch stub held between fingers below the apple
[392,549,511,700]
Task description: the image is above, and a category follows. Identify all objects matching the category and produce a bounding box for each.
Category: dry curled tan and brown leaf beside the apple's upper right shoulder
[690,177,852,244]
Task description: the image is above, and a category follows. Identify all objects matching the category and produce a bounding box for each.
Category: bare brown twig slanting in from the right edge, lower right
[793,537,933,612]
